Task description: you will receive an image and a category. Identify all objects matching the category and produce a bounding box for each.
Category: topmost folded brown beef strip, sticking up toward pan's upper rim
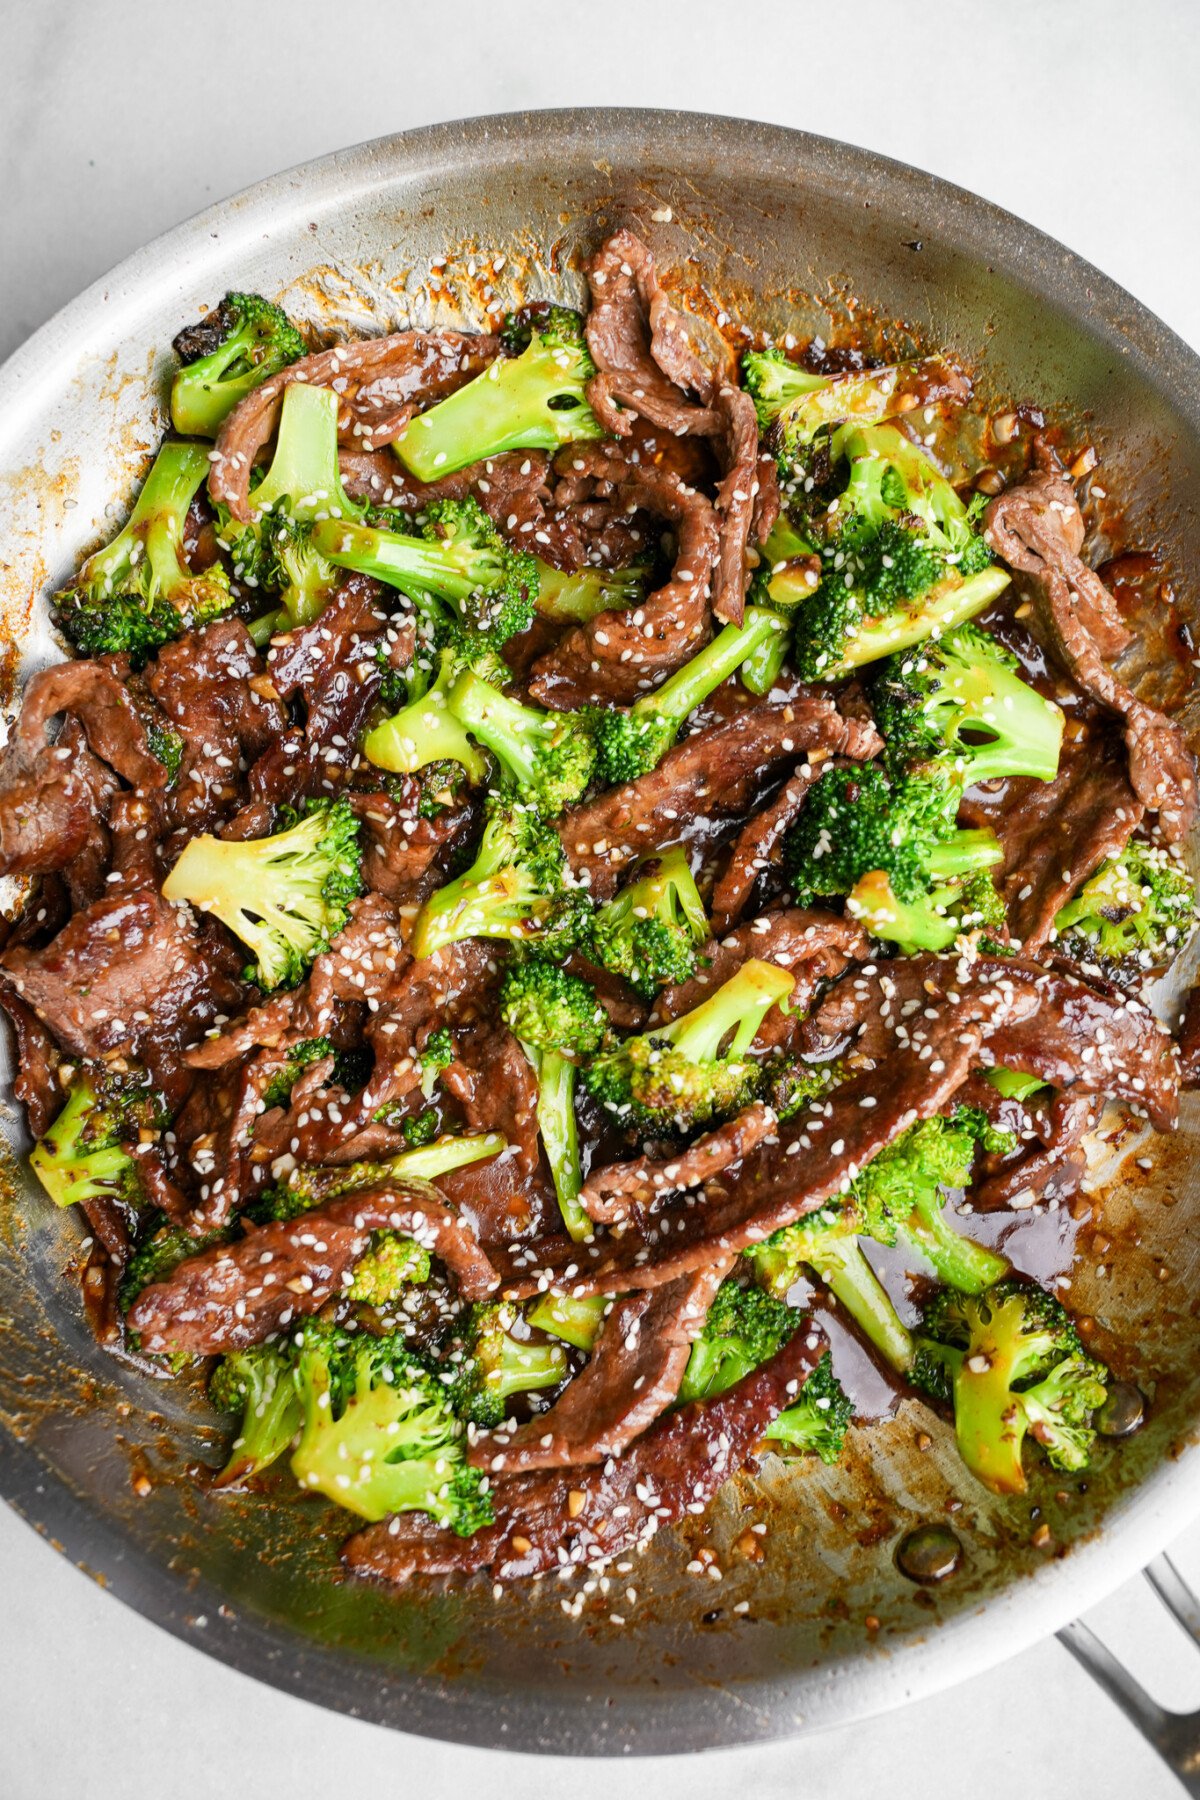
[587,229,720,437]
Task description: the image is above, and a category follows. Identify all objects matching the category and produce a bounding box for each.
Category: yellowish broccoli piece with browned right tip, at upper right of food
[741,346,964,457]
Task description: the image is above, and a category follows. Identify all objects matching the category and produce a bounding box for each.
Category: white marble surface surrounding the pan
[0,0,1200,1800]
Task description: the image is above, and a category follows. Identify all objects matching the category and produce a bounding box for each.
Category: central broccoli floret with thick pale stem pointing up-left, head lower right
[450,670,596,814]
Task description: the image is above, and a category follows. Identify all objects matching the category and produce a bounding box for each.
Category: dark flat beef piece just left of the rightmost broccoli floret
[961,724,1144,956]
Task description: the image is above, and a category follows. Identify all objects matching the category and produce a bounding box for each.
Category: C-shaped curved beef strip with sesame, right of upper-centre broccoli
[529,443,720,711]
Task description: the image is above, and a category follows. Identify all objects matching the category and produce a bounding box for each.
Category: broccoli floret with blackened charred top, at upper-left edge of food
[171,293,308,437]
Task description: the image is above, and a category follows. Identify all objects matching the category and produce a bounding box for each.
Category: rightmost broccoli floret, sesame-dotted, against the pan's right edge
[1054,839,1196,976]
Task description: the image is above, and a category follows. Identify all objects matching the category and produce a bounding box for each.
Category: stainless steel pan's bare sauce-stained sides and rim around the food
[0,112,1200,1753]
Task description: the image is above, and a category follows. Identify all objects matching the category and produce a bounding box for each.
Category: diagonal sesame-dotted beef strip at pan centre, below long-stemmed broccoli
[558,695,880,900]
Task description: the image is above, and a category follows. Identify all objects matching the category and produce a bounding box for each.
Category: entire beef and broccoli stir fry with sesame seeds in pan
[0,230,1200,1582]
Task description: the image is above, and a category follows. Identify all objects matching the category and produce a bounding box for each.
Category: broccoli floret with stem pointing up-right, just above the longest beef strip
[583,959,795,1134]
